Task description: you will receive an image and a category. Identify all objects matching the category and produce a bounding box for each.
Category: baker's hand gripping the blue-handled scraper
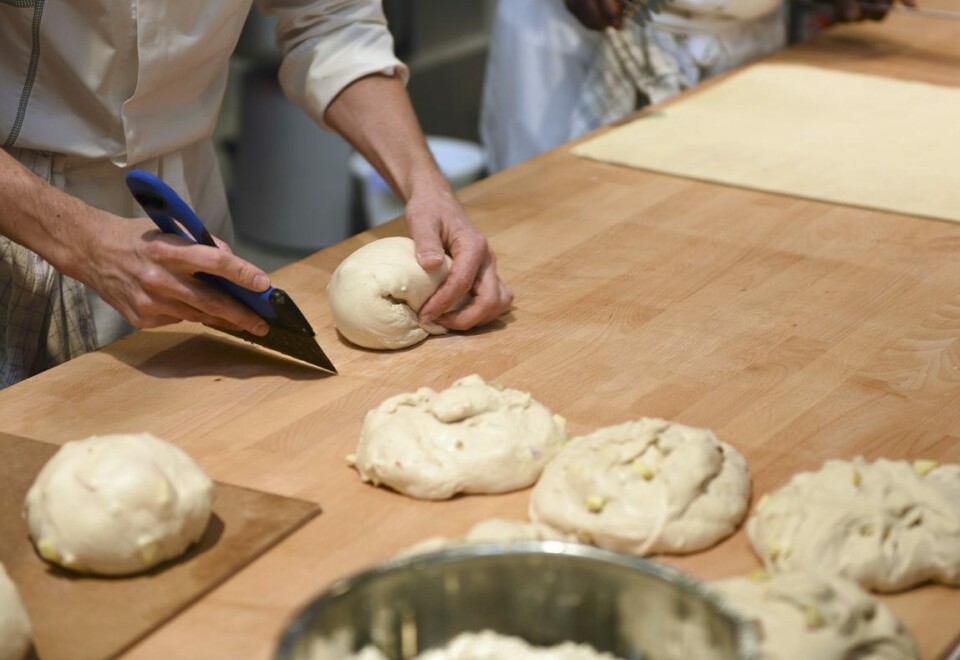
[75,215,270,336]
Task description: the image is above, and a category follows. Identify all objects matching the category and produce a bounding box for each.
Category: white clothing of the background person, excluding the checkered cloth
[480,0,786,172]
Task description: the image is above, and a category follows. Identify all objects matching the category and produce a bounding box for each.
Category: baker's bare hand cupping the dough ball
[405,192,513,330]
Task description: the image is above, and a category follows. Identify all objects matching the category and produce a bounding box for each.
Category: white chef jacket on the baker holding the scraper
[0,0,408,378]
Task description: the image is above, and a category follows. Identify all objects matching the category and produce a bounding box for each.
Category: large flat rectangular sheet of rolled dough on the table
[572,63,960,222]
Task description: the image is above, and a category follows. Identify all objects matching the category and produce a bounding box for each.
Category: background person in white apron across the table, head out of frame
[480,0,908,173]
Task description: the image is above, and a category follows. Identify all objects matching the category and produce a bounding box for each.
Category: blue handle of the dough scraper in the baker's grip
[127,170,277,320]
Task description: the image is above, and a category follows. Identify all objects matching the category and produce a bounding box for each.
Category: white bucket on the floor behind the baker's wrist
[350,135,486,227]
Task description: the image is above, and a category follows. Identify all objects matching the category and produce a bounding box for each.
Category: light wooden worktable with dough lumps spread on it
[0,15,960,658]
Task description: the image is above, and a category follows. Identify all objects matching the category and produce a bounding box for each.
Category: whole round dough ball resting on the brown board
[24,433,213,575]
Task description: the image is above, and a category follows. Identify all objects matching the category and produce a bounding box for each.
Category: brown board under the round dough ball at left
[0,433,320,660]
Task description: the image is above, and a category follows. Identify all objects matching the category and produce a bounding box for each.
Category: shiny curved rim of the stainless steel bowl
[275,541,762,660]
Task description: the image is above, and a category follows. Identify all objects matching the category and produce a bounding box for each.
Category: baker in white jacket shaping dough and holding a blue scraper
[0,0,512,387]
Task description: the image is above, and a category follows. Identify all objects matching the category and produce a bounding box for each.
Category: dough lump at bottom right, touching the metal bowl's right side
[713,571,917,660]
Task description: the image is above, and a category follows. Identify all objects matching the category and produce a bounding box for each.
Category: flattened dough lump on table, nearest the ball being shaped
[355,375,566,500]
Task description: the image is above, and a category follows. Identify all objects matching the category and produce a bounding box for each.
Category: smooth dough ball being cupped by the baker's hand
[327,236,451,349]
